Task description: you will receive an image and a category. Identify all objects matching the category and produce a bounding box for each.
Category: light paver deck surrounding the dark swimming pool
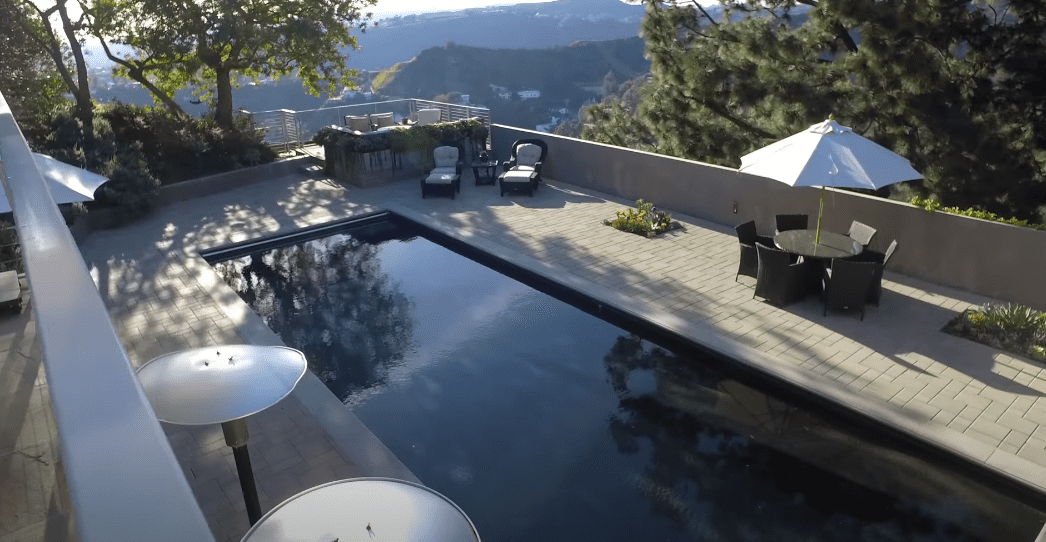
[0,164,1046,542]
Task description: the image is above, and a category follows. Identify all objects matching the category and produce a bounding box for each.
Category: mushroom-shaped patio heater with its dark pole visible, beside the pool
[138,344,306,525]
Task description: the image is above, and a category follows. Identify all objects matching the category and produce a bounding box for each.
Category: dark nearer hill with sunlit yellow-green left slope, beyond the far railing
[373,38,650,104]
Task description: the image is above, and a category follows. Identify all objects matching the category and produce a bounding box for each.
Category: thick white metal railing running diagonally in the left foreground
[0,94,214,542]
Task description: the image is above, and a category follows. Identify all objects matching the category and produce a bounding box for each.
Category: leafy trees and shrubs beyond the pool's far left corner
[0,0,376,218]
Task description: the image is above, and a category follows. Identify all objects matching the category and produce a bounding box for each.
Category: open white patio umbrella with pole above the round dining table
[738,118,923,243]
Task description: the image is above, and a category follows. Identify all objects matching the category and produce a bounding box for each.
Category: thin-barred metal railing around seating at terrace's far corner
[248,98,491,150]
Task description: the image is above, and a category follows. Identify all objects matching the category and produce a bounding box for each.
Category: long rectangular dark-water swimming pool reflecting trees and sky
[208,217,1046,542]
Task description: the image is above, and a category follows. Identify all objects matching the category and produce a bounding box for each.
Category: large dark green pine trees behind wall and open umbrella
[583,0,1046,223]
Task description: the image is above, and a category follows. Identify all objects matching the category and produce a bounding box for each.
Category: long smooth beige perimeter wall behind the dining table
[491,125,1046,310]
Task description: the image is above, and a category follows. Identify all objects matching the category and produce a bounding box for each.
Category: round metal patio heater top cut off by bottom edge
[241,478,479,542]
